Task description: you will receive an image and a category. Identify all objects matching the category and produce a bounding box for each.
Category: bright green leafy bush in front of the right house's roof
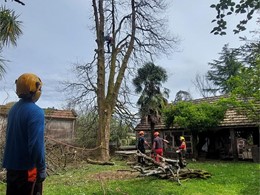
[163,101,227,131]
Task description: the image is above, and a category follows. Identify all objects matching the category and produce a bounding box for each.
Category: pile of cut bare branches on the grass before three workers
[132,151,211,184]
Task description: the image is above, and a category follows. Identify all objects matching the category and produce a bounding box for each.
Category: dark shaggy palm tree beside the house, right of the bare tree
[133,62,169,142]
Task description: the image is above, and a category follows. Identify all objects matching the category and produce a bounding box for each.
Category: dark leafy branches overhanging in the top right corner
[210,0,260,35]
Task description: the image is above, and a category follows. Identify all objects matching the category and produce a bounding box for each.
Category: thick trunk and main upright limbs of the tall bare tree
[92,0,136,161]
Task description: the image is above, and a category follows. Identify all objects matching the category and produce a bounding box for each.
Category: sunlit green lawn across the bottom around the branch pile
[0,161,260,195]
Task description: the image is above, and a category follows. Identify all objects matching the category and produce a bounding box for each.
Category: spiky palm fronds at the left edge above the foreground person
[0,6,22,79]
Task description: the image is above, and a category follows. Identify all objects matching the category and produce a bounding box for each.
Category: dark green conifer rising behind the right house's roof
[205,45,243,94]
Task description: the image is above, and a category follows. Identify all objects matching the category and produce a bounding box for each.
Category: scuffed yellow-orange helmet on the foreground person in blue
[15,73,42,102]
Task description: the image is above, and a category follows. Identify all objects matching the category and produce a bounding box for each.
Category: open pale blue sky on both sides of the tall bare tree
[0,0,256,108]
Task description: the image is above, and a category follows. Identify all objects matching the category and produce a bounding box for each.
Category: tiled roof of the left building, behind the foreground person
[0,105,77,119]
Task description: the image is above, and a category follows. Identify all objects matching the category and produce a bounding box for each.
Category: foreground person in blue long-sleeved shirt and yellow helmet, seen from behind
[3,73,46,195]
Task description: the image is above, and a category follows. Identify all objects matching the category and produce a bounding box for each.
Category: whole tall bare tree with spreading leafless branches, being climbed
[63,0,177,160]
